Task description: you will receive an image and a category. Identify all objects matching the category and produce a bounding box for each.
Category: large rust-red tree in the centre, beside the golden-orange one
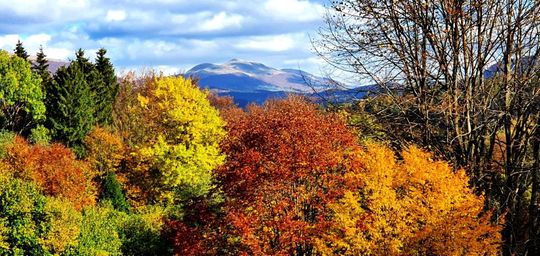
[213,97,355,255]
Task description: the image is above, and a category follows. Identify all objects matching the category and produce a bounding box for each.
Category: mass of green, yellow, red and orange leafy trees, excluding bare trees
[0,41,502,255]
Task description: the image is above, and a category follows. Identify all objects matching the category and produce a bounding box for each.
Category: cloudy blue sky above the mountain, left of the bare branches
[0,0,328,74]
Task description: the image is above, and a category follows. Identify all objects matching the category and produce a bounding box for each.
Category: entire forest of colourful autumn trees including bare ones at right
[0,0,540,255]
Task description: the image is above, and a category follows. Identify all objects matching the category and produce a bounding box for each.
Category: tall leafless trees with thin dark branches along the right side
[314,0,540,254]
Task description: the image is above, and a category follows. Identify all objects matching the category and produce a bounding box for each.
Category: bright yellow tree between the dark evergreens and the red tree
[121,77,225,206]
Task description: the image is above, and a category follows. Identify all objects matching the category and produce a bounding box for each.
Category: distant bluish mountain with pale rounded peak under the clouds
[185,59,368,106]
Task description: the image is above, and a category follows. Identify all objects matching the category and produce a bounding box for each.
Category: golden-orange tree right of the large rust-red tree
[317,143,501,255]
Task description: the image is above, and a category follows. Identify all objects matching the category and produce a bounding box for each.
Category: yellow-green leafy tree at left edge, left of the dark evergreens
[0,50,45,134]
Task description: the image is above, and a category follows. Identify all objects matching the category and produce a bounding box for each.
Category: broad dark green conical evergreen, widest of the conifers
[47,60,95,156]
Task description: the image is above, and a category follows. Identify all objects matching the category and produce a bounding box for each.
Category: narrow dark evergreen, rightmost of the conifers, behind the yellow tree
[95,48,119,125]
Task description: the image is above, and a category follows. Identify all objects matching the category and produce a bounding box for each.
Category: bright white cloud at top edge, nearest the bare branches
[263,0,324,21]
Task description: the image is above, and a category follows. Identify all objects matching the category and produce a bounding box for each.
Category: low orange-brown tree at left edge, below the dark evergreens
[2,137,95,209]
